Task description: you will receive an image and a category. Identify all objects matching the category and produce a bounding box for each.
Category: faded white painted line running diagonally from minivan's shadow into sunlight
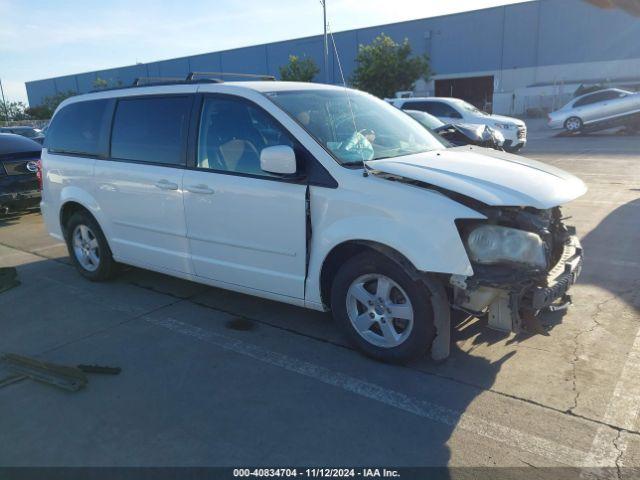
[141,316,592,465]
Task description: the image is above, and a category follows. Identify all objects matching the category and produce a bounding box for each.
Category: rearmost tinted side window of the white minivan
[45,100,110,156]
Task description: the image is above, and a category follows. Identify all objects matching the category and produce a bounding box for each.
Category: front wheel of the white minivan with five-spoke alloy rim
[331,252,436,363]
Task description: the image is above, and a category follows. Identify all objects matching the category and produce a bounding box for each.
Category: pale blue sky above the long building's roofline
[0,0,518,101]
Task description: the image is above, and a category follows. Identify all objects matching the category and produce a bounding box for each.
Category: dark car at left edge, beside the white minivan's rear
[0,133,42,214]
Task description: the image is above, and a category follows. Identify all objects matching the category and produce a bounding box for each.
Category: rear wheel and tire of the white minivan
[66,211,117,282]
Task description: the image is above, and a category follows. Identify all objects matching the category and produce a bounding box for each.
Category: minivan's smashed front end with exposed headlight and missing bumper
[450,206,582,333]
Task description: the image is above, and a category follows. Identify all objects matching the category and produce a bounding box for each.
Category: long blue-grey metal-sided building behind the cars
[26,0,640,114]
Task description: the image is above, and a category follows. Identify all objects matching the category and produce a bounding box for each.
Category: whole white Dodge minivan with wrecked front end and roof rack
[41,81,586,362]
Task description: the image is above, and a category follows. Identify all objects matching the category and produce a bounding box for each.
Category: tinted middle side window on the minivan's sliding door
[111,96,192,165]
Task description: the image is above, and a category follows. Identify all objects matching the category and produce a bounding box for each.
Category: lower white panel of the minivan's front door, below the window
[184,170,306,298]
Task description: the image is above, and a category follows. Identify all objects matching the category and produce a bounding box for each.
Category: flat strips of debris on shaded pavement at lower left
[0,353,122,392]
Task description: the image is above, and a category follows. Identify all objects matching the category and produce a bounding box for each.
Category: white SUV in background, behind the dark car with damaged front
[387,97,527,153]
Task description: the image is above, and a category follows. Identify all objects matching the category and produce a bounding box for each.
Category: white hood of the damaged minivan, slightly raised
[367,146,587,209]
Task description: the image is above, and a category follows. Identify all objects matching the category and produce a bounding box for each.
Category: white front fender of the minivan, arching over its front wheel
[306,180,486,305]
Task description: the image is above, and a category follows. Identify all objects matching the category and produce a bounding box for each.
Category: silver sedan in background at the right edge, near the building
[548,88,640,132]
